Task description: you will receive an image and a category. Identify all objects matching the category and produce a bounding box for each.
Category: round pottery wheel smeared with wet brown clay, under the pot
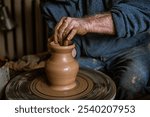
[5,68,116,100]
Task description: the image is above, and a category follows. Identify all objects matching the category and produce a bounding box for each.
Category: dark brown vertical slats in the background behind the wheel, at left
[0,0,48,59]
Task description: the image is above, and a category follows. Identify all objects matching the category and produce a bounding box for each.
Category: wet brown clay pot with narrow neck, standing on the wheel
[45,42,79,91]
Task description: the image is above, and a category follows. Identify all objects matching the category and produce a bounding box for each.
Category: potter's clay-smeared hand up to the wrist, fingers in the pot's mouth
[54,17,89,45]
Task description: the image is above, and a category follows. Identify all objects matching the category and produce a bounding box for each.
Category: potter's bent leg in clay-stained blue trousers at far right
[107,45,150,99]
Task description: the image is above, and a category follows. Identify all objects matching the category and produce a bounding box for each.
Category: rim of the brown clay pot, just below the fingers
[49,42,75,50]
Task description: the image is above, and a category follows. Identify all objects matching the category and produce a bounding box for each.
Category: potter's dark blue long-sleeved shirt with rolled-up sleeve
[41,0,150,57]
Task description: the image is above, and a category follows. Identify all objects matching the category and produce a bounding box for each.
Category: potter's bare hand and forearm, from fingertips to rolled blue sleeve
[51,13,115,45]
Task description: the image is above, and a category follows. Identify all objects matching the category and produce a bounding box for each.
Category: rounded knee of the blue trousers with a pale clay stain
[118,62,149,99]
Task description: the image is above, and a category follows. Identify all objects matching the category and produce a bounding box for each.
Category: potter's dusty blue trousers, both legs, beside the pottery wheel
[77,37,150,99]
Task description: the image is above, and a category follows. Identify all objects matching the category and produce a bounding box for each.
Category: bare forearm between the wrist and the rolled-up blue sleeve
[87,13,115,35]
